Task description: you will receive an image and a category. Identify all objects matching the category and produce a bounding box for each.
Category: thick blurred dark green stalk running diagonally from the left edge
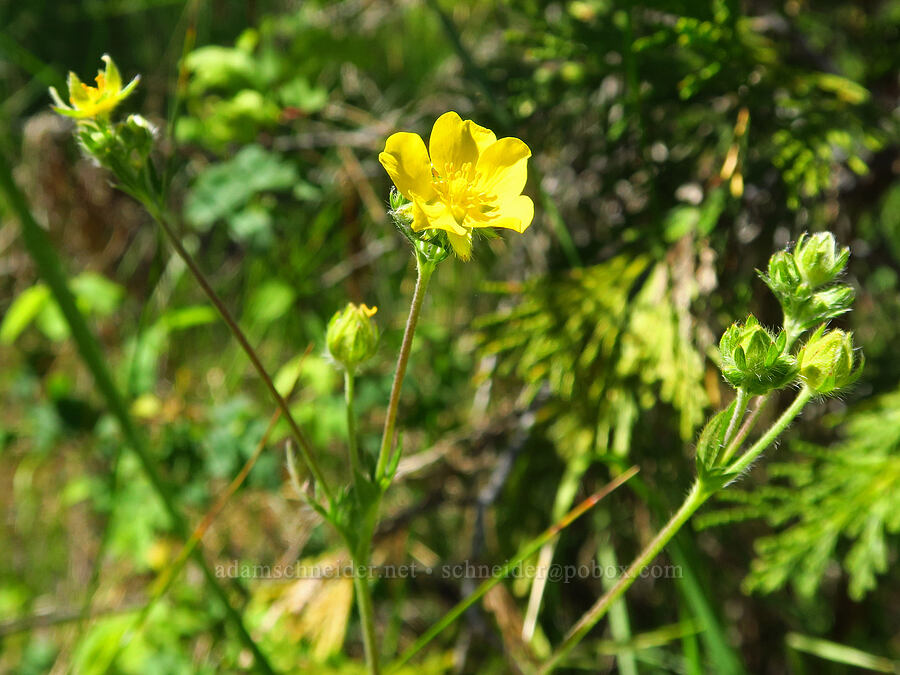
[0,155,274,673]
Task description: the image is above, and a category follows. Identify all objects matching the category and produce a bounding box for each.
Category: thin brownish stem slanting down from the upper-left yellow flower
[144,206,333,504]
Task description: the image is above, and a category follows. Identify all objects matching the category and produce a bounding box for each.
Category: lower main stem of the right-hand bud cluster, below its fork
[538,483,712,675]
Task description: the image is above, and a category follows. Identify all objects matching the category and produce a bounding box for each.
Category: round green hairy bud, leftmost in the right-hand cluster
[719,314,797,396]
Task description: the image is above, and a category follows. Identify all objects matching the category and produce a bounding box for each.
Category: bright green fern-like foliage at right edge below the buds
[695,391,900,600]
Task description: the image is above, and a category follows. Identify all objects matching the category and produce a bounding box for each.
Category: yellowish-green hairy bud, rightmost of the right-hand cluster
[797,325,864,394]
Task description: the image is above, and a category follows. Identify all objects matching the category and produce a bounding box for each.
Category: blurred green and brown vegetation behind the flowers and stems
[0,0,900,675]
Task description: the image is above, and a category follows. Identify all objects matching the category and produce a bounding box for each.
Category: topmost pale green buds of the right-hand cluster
[760,232,855,340]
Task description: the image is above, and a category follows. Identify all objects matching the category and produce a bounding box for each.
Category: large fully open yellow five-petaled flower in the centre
[378,112,534,260]
